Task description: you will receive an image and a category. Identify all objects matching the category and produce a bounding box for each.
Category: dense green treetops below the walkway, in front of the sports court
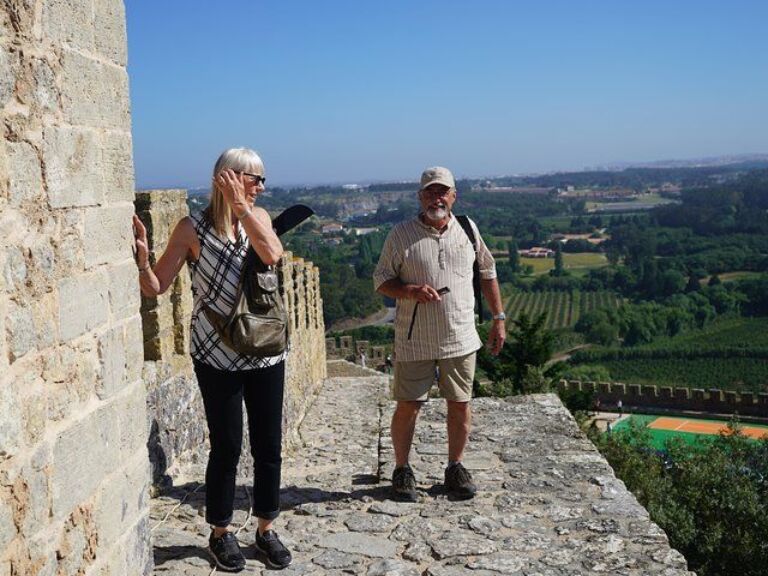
[590,424,768,576]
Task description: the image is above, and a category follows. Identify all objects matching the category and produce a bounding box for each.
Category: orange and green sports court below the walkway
[613,414,768,449]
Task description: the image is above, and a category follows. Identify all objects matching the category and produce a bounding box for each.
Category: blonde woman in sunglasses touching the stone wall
[133,148,291,572]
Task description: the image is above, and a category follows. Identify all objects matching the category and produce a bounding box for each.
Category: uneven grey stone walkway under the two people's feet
[147,368,692,576]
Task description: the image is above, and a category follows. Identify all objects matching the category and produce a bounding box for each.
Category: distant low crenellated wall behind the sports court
[559,380,768,418]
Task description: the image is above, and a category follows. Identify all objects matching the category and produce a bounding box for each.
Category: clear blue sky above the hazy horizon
[125,0,768,188]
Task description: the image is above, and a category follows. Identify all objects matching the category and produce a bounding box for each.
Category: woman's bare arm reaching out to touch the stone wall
[133,215,200,297]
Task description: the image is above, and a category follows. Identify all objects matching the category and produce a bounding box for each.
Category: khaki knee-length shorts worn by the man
[392,352,476,402]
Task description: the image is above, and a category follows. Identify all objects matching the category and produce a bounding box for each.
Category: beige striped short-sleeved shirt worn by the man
[373,216,496,361]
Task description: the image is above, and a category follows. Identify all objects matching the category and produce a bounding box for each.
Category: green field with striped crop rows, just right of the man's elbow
[505,291,620,329]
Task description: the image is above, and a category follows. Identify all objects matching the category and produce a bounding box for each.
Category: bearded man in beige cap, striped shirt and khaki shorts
[373,167,506,501]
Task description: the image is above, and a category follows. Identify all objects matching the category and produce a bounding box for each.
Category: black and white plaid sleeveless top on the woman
[190,214,287,371]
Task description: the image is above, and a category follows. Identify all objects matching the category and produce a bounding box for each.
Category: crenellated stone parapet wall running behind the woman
[136,190,326,483]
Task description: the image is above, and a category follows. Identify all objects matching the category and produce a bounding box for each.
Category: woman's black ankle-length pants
[194,361,285,527]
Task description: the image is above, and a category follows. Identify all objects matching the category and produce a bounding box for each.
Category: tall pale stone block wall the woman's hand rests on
[0,0,151,576]
